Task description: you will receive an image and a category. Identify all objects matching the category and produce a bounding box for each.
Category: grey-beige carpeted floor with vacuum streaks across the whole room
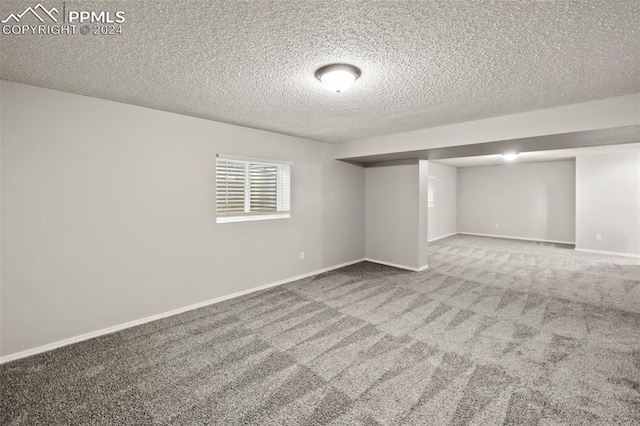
[0,236,640,425]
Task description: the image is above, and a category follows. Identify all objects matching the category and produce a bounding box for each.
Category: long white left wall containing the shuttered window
[0,81,365,355]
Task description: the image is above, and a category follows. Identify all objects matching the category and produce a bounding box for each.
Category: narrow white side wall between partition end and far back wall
[429,161,458,241]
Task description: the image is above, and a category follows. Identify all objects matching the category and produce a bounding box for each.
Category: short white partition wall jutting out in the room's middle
[365,160,427,269]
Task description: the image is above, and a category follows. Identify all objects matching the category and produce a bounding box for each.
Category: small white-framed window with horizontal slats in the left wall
[216,155,291,223]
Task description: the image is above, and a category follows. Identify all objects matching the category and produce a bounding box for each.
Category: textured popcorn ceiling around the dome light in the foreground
[0,0,640,142]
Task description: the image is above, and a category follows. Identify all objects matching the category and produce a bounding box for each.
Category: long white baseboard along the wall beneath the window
[0,259,365,364]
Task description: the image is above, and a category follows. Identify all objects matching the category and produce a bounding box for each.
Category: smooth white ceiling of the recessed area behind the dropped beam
[434,143,640,167]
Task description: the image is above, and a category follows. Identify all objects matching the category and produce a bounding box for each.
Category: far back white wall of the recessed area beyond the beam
[458,161,576,243]
